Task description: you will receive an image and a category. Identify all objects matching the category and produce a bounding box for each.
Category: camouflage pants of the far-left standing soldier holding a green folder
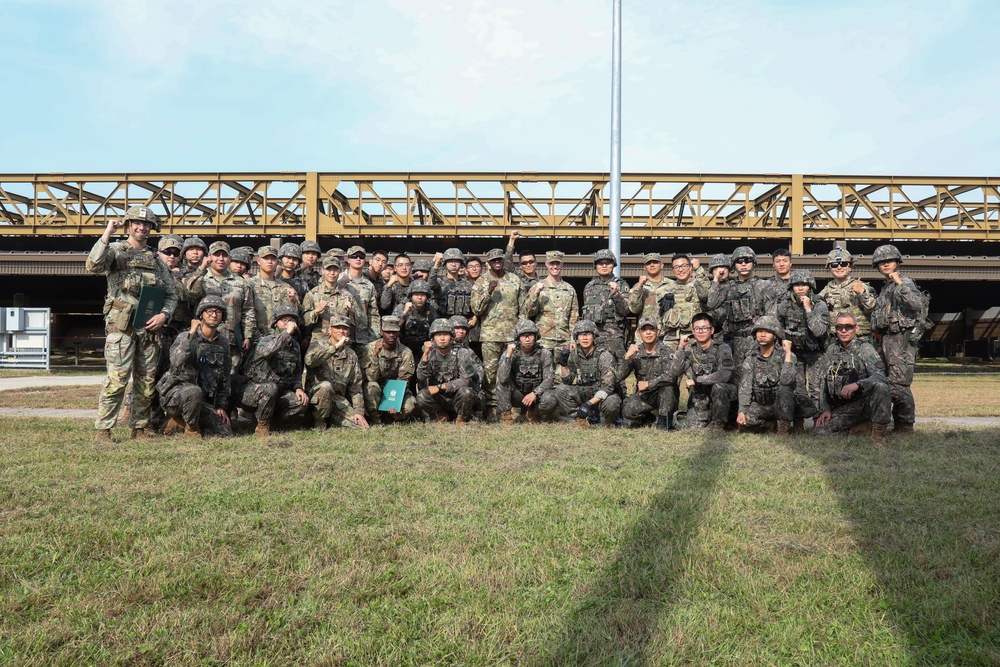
[94,333,160,430]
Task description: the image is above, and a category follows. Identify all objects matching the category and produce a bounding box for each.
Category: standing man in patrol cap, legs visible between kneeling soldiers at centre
[472,249,526,421]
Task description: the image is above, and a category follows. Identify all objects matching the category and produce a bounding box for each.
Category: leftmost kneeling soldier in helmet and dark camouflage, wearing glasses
[156,295,233,438]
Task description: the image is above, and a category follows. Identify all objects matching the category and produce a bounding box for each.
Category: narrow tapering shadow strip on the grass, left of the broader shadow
[535,436,728,665]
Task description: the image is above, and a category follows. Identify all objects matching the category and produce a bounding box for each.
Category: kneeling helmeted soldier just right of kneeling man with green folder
[417,318,481,424]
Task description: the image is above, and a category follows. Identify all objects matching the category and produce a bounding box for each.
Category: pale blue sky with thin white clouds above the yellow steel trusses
[0,0,1000,176]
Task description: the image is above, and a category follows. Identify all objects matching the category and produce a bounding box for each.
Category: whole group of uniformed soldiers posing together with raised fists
[87,206,927,446]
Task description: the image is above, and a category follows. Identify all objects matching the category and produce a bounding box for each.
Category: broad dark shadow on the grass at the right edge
[793,428,1000,665]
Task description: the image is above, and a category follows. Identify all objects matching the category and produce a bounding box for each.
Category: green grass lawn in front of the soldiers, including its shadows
[0,420,1000,665]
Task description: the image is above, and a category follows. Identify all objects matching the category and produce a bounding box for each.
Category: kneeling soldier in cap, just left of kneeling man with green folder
[306,317,368,431]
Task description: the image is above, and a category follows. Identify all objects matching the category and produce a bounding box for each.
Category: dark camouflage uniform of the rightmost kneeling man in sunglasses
[814,338,892,434]
